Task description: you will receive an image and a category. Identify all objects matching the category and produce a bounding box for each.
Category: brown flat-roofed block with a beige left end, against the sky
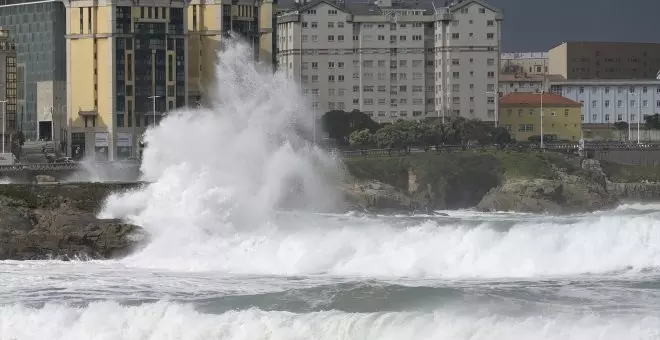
[548,41,660,79]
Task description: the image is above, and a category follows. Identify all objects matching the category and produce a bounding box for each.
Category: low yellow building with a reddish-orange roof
[498,92,582,142]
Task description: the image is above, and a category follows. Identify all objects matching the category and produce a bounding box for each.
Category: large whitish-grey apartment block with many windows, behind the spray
[277,0,502,122]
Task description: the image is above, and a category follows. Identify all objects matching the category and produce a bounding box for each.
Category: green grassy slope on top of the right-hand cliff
[345,151,575,208]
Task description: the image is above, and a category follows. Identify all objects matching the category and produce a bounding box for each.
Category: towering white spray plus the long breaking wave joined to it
[96,39,660,278]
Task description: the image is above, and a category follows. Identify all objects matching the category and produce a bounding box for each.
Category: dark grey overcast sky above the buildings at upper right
[280,0,660,52]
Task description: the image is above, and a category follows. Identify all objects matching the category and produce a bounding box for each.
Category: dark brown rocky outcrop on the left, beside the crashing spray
[0,183,146,260]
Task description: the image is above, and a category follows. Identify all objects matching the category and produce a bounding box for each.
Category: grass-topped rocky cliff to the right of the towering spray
[345,151,618,214]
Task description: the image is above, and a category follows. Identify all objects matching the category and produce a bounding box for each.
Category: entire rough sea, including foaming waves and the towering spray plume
[0,42,660,340]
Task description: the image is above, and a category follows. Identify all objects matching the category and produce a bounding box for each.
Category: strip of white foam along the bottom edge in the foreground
[0,302,660,340]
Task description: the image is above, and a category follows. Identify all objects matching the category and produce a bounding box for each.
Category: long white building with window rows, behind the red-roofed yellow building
[550,79,660,124]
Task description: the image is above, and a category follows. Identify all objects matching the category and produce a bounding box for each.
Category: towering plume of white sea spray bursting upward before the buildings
[101,41,340,262]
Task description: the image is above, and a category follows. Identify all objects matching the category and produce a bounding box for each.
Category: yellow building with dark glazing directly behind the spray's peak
[187,0,277,103]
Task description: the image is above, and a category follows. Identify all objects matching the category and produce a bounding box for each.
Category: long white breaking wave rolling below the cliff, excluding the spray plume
[107,212,660,278]
